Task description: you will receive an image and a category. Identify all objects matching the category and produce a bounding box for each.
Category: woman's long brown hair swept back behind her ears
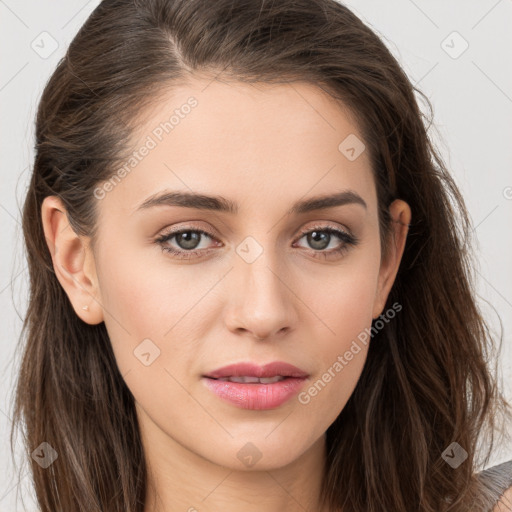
[11,0,508,512]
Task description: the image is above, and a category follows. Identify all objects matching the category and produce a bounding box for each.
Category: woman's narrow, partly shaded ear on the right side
[372,199,411,319]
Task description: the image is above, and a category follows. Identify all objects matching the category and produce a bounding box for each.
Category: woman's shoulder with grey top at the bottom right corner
[478,460,512,512]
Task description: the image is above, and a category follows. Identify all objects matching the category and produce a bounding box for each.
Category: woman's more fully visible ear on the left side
[41,196,103,325]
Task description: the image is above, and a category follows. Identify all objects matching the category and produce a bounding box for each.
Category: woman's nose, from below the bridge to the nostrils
[225,252,298,340]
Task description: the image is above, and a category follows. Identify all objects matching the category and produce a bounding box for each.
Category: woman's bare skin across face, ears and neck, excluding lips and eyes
[42,78,411,512]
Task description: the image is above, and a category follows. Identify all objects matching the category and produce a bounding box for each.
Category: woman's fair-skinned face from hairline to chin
[43,79,409,469]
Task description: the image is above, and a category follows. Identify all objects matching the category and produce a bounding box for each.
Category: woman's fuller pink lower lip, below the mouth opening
[203,377,306,411]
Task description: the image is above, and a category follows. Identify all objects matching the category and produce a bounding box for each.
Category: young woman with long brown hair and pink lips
[10,0,512,512]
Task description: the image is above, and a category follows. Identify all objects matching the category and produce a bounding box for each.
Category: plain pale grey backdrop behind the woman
[0,0,512,512]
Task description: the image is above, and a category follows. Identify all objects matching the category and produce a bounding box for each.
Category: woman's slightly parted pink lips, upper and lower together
[203,361,308,410]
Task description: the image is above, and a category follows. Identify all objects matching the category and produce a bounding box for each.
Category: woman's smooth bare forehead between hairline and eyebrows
[97,78,375,215]
